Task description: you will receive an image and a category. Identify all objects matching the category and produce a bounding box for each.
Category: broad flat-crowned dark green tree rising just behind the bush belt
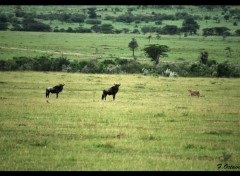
[143,44,170,65]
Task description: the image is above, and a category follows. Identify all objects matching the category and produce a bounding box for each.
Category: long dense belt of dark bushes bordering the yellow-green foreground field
[0,55,240,77]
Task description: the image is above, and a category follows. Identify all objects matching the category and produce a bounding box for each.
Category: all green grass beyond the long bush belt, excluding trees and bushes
[0,5,240,64]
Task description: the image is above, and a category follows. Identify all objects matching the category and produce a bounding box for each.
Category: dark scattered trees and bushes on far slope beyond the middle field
[0,6,240,37]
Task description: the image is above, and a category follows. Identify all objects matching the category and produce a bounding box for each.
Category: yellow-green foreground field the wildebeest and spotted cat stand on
[0,71,240,171]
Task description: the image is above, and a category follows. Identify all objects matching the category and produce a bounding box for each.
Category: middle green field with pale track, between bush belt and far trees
[0,31,240,63]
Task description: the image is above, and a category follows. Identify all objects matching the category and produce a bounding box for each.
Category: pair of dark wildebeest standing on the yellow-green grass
[46,84,121,100]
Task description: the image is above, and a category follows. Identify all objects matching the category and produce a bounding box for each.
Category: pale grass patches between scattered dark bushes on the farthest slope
[0,5,240,34]
